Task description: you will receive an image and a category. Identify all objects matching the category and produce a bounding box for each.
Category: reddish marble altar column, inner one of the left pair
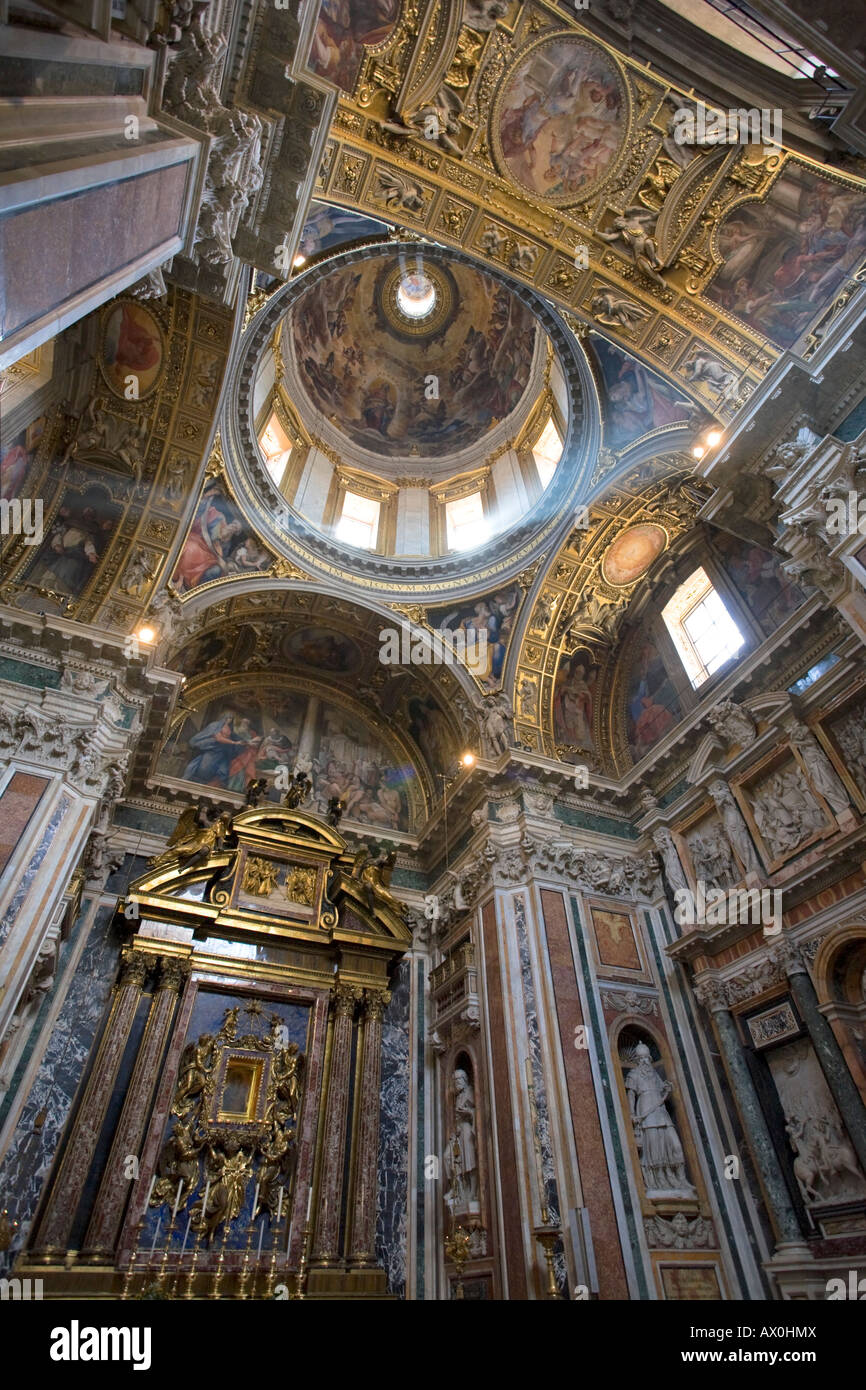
[82,956,189,1261]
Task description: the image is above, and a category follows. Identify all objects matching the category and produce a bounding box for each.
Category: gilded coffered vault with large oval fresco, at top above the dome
[318,3,866,420]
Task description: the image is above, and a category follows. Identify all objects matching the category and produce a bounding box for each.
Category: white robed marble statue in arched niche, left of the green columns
[620,1043,695,1197]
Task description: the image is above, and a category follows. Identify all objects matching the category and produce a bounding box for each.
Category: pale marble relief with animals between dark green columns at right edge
[767,1038,866,1207]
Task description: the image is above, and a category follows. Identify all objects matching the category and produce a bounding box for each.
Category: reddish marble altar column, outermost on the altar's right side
[349,990,391,1265]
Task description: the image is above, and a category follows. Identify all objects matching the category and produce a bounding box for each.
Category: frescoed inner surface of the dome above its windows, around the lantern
[286,254,539,459]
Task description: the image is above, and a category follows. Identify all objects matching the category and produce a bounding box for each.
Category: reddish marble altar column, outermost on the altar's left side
[33,949,153,1264]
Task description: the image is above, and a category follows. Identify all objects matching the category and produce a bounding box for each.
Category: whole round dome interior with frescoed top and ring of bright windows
[225,242,598,588]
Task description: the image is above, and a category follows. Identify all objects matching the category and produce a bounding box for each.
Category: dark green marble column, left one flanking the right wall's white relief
[695,980,805,1247]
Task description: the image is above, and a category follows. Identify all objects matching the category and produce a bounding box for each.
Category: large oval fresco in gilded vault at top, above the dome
[492,35,628,206]
